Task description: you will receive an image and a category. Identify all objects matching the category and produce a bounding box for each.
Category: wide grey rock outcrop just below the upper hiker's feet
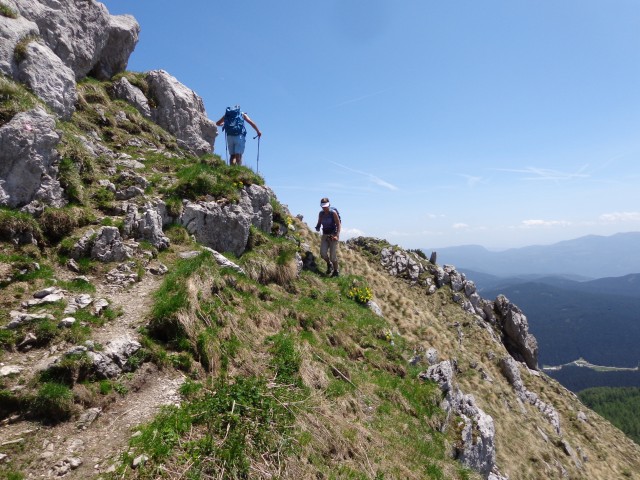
[179,185,273,255]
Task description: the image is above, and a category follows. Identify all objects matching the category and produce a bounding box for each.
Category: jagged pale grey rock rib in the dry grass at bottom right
[419,361,496,478]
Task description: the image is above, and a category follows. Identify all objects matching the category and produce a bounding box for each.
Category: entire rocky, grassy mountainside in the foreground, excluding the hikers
[0,0,640,480]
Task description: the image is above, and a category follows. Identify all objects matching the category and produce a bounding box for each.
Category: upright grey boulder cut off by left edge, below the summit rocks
[0,108,66,208]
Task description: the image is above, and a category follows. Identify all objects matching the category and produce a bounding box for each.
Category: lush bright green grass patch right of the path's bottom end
[119,377,295,478]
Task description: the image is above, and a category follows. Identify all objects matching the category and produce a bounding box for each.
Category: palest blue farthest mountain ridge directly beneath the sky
[423,232,640,280]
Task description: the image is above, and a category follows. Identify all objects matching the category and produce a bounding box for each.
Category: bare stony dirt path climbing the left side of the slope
[0,264,184,479]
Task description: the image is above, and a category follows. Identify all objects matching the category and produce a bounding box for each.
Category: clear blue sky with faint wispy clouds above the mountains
[103,0,640,250]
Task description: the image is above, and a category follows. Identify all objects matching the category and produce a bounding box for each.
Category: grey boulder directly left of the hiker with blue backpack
[146,70,218,155]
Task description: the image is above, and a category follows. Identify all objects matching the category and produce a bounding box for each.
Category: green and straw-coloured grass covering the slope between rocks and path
[2,73,640,479]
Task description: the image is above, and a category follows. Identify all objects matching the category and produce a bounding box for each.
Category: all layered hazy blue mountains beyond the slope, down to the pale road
[424,232,640,388]
